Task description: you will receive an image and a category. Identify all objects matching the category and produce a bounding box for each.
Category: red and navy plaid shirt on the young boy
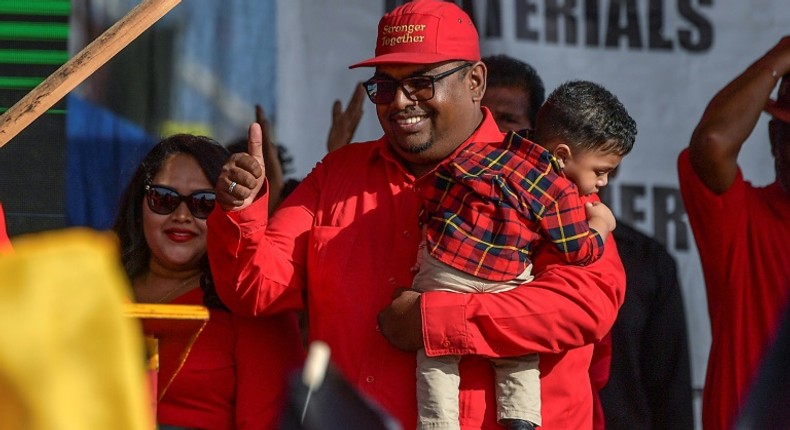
[421,132,603,281]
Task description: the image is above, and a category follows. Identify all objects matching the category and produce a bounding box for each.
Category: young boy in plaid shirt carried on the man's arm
[413,81,636,429]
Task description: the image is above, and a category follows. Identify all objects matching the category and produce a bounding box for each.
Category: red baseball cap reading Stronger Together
[348,0,480,69]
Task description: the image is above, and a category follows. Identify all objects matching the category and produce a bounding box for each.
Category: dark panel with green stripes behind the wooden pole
[0,0,71,236]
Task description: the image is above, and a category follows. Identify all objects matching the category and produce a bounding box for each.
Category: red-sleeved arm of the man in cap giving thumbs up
[207,123,312,315]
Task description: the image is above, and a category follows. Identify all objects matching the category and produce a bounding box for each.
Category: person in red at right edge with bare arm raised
[678,36,790,430]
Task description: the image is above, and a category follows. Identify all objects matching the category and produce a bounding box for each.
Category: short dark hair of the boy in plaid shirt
[532,81,636,156]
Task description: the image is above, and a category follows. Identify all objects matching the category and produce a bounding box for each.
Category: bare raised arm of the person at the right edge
[689,36,790,194]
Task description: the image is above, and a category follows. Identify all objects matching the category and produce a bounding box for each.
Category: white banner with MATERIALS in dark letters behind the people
[276,0,790,404]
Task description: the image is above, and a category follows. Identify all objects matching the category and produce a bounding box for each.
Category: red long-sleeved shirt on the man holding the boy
[208,110,625,430]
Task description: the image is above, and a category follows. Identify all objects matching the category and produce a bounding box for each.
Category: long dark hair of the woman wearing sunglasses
[113,134,230,307]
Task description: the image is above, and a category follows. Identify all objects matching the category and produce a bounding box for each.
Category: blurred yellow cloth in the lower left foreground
[0,228,154,430]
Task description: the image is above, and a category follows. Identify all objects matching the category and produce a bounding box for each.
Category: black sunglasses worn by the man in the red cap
[362,62,473,105]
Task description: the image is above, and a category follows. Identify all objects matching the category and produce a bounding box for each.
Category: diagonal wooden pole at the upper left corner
[0,0,181,147]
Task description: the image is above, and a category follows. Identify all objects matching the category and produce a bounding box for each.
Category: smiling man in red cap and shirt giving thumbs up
[208,0,625,429]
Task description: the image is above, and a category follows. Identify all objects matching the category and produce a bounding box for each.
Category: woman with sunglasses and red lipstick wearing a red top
[114,134,304,429]
